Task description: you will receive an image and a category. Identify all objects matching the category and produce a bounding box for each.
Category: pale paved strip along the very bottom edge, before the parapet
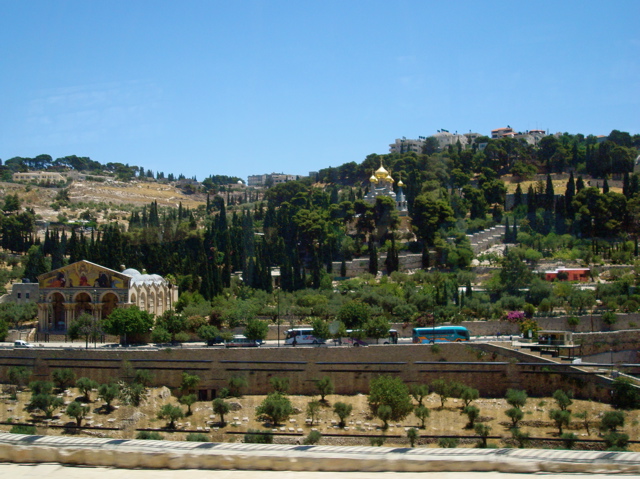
[0,464,638,479]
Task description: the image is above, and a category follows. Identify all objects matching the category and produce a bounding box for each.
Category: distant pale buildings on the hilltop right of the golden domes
[389,126,549,153]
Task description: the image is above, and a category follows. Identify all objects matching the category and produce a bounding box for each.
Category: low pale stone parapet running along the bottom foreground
[0,433,640,474]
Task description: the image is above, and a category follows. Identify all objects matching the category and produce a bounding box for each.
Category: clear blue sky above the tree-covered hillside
[0,0,640,180]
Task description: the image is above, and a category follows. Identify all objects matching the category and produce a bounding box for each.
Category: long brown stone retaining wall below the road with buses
[0,343,620,400]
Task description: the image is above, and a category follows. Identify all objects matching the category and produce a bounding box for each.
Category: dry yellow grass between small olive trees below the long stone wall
[0,388,640,451]
